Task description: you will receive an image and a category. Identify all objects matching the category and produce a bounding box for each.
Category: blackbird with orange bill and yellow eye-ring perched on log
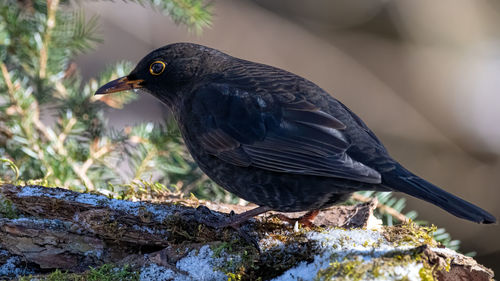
[96,43,496,226]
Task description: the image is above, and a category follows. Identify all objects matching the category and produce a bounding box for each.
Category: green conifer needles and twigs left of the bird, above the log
[0,0,215,197]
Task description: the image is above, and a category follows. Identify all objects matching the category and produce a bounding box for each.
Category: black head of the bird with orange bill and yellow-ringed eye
[95,43,224,106]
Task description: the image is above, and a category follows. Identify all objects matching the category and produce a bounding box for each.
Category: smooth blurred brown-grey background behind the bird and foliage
[76,0,500,272]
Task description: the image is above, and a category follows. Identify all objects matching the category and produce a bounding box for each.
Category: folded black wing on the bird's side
[193,84,381,183]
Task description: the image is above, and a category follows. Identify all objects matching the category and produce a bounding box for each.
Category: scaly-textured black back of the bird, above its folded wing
[218,57,393,164]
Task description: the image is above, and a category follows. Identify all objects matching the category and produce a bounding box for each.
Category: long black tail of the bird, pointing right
[382,164,496,223]
